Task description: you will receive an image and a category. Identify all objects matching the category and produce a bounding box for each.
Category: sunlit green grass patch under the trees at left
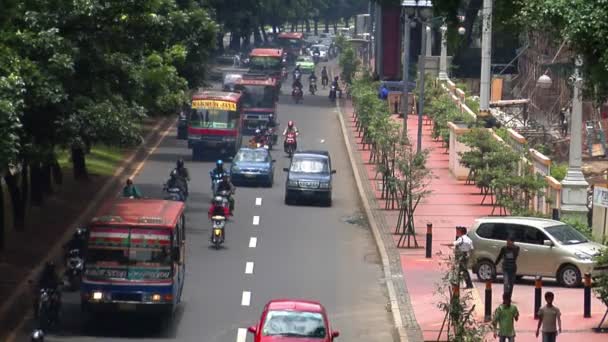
[57,145,125,176]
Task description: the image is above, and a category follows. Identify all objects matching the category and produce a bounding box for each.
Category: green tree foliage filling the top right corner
[516,0,608,103]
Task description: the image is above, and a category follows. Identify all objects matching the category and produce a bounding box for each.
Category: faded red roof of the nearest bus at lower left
[91,198,185,228]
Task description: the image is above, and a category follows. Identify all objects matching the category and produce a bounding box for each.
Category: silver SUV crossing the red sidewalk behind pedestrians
[468,216,605,287]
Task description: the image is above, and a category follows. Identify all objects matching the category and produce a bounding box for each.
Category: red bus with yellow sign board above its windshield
[188,91,243,160]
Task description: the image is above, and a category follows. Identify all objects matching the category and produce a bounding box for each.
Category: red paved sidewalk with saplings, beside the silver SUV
[345,107,608,342]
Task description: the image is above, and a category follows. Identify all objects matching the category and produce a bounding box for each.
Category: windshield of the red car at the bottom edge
[262,310,327,338]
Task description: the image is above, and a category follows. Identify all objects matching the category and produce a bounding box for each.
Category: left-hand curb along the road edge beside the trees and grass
[0,117,177,341]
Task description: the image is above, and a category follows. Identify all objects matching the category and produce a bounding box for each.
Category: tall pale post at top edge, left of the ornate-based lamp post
[479,0,494,117]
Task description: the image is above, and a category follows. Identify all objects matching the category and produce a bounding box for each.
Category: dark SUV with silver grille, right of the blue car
[283,151,336,206]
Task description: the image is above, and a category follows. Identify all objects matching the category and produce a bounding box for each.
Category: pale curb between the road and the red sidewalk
[336,101,422,342]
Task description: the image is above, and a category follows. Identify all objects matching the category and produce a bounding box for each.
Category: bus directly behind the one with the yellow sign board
[234,74,279,132]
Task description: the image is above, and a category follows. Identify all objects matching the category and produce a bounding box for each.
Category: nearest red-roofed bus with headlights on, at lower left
[81,198,186,315]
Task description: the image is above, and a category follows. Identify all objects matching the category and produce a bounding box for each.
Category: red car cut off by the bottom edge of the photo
[248,299,340,342]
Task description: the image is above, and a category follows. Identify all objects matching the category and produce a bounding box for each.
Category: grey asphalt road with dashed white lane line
[17,63,393,342]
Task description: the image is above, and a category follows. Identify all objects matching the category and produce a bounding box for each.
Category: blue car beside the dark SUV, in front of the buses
[230,147,275,187]
